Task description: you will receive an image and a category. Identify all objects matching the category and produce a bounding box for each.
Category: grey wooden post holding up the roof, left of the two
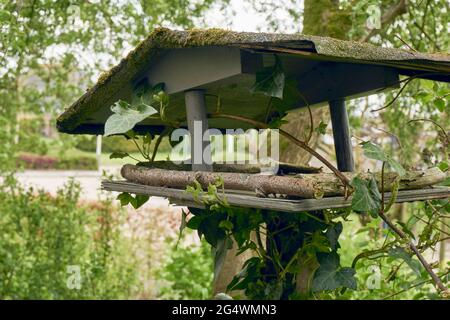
[184,90,212,171]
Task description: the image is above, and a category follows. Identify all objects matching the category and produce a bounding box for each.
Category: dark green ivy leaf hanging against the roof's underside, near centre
[250,56,284,99]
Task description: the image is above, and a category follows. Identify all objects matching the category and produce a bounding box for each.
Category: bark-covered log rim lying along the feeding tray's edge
[121,164,446,199]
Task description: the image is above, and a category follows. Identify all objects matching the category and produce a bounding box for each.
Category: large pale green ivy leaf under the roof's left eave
[105,100,158,136]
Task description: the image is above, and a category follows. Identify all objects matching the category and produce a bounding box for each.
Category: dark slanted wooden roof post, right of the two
[329,99,355,172]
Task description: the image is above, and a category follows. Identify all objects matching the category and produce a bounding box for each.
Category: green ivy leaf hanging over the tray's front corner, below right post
[351,176,381,218]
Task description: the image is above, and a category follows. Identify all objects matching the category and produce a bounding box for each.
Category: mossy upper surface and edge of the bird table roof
[57,28,450,133]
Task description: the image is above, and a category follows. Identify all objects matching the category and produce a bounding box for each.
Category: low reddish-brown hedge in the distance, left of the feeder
[17,153,97,170]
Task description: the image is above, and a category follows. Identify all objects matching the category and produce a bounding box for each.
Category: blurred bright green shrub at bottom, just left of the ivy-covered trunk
[158,230,213,299]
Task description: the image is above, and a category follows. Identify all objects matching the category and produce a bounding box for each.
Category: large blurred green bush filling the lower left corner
[0,182,140,299]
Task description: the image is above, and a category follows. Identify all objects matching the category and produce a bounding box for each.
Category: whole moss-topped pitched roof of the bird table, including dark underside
[57,28,450,134]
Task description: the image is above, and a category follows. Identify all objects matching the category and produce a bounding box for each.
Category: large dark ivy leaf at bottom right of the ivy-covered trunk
[312,251,357,292]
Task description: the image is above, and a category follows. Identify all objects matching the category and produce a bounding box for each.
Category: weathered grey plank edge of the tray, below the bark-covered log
[102,180,450,212]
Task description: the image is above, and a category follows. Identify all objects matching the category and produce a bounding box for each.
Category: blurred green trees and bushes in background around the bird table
[0,0,450,299]
